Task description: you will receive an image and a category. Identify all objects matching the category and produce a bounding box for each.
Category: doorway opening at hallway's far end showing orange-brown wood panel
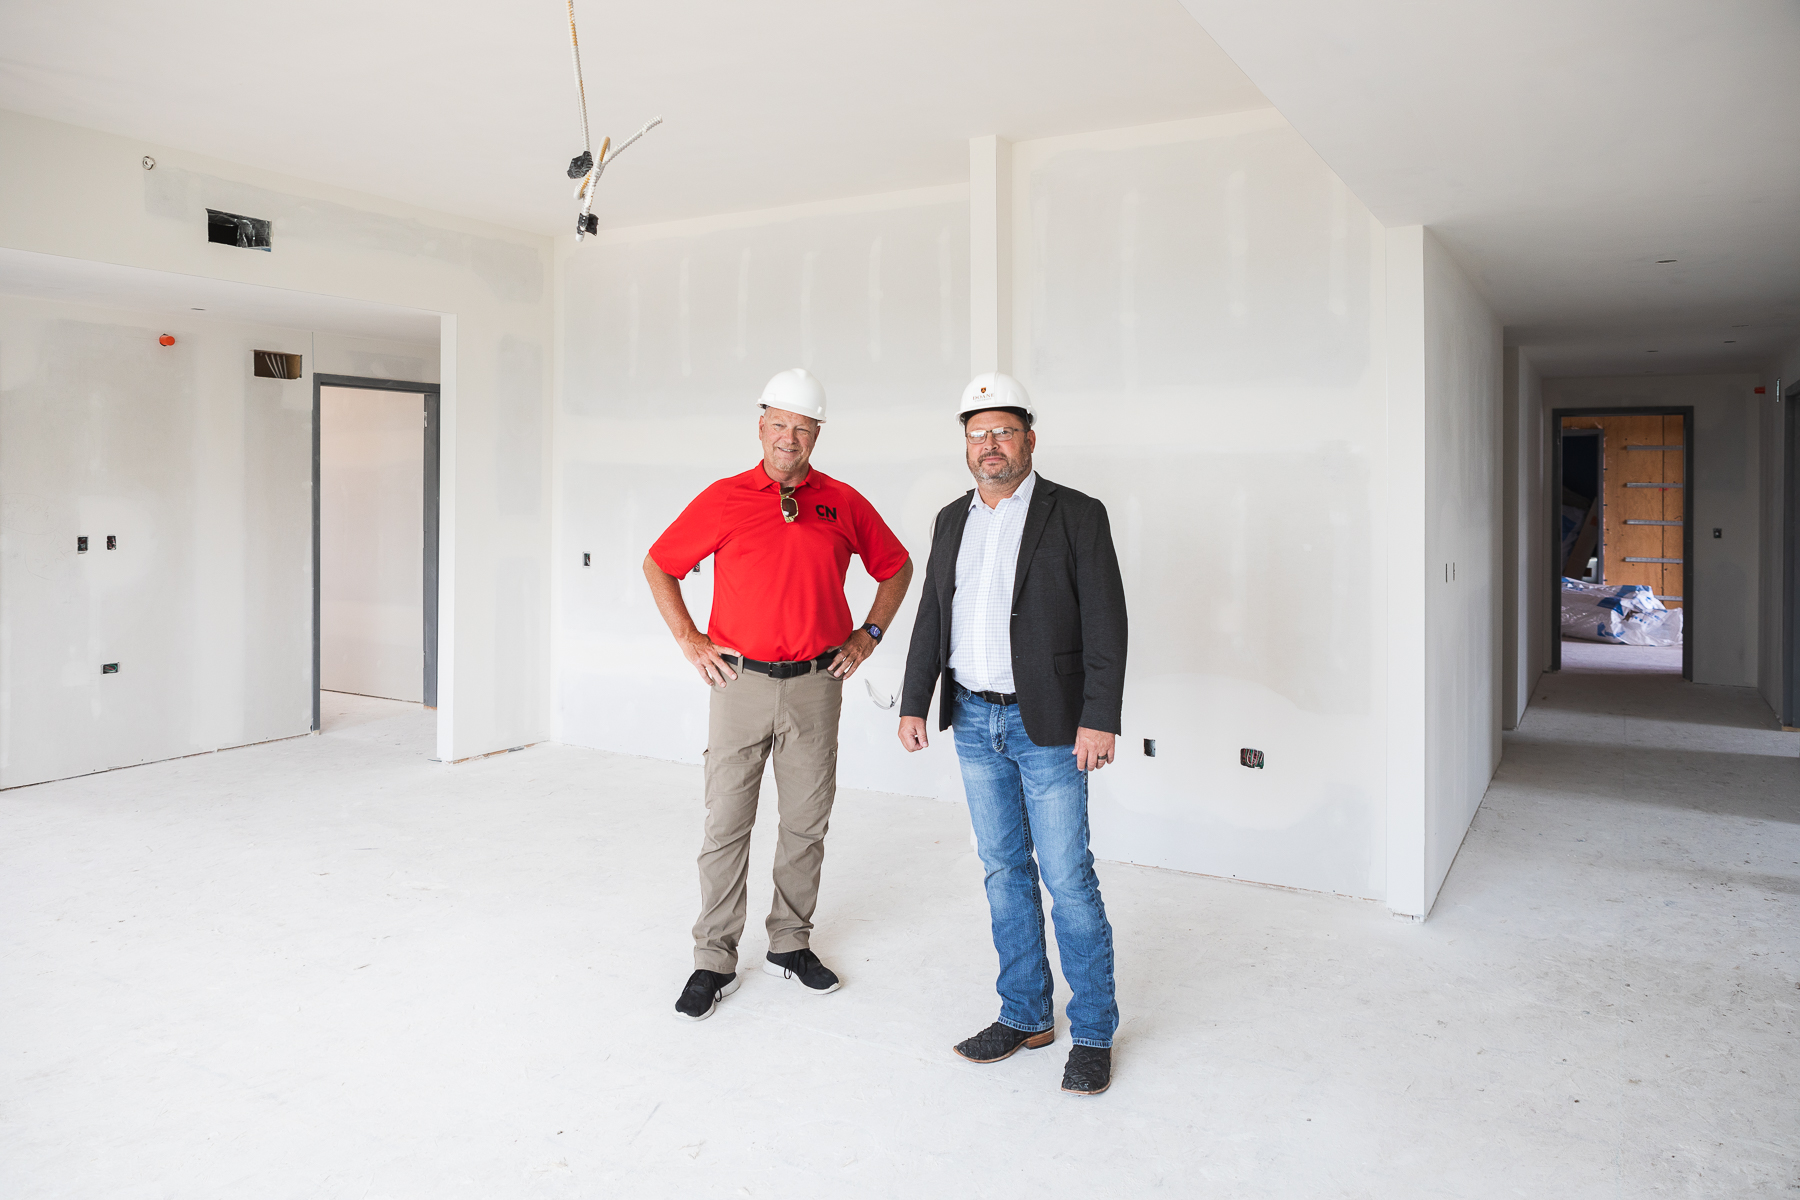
[1548,407,1696,680]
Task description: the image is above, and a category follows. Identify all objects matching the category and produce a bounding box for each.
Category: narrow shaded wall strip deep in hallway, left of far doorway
[1499,345,1550,729]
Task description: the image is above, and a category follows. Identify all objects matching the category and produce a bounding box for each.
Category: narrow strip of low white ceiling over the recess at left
[0,246,441,345]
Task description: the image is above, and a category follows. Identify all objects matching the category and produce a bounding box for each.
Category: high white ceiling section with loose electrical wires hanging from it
[0,0,1267,234]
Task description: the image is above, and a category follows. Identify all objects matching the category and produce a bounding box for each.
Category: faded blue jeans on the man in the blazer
[954,687,1120,1047]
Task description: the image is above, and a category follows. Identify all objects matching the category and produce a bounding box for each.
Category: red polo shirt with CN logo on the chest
[650,462,907,662]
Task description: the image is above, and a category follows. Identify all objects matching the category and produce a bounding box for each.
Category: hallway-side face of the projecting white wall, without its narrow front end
[1422,230,1505,912]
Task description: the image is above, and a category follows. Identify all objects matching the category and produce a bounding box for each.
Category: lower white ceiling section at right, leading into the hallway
[1183,0,1800,374]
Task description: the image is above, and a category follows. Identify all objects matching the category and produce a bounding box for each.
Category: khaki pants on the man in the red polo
[693,669,844,973]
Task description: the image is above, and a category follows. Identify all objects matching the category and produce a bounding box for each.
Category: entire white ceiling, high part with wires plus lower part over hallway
[0,0,1800,374]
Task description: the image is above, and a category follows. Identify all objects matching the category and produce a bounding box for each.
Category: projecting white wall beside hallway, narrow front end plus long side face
[1386,225,1507,918]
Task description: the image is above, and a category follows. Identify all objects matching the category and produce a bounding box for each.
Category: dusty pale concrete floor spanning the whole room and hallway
[0,676,1800,1200]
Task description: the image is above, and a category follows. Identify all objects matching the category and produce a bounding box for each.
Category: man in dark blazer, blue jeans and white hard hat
[900,372,1125,1096]
